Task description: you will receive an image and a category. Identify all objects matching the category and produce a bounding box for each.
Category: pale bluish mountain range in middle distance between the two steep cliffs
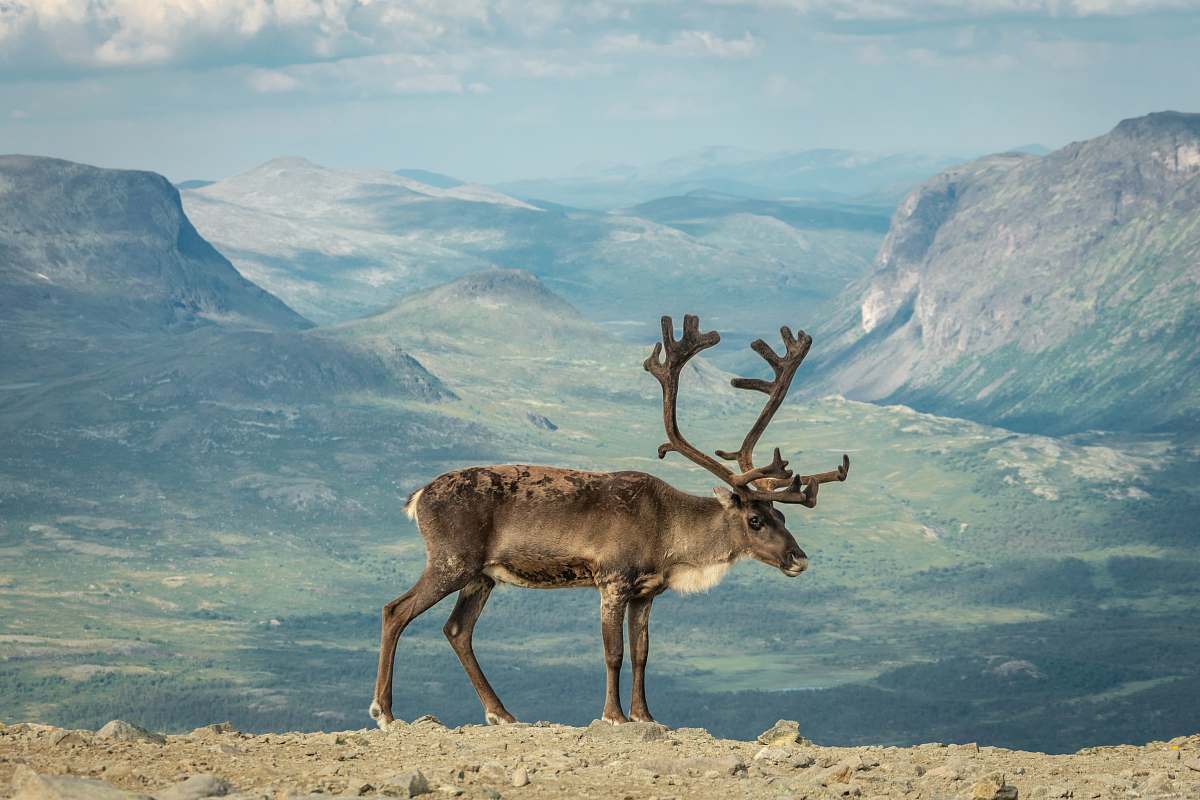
[177,158,883,335]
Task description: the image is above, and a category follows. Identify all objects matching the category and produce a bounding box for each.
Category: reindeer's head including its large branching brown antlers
[643,314,850,576]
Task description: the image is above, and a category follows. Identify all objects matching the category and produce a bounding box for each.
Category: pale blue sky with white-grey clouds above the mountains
[0,0,1200,182]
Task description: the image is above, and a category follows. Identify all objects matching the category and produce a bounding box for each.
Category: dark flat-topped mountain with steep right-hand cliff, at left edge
[0,156,311,333]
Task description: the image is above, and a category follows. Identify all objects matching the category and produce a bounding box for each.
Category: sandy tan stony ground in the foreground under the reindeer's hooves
[0,717,1200,800]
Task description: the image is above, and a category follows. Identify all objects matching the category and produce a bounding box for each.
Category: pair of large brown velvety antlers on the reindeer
[642,314,850,509]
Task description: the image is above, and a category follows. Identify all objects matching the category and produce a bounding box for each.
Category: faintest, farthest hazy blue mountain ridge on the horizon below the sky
[497,146,961,209]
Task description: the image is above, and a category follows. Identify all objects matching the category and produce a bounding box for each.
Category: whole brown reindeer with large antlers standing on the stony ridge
[371,314,850,728]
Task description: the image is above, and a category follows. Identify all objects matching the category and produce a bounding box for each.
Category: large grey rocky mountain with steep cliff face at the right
[814,112,1200,432]
